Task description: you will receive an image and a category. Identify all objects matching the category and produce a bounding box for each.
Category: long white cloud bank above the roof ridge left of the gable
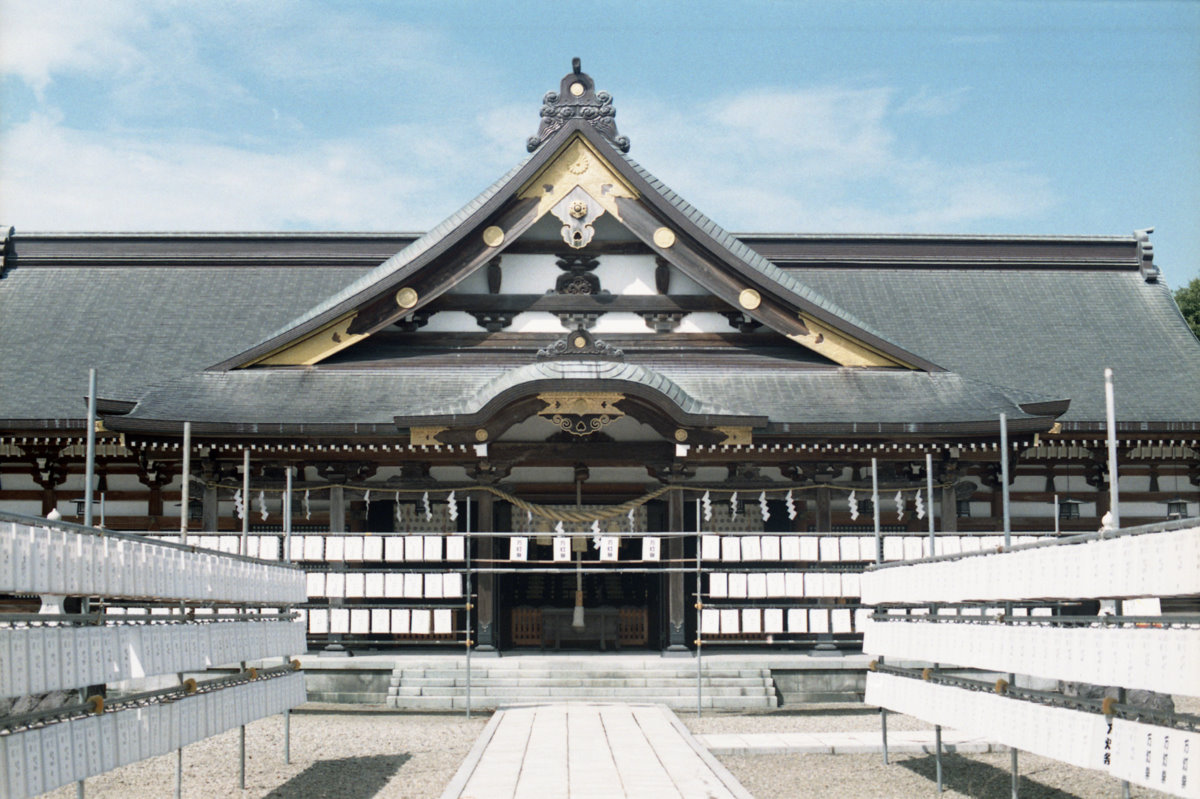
[0,114,498,230]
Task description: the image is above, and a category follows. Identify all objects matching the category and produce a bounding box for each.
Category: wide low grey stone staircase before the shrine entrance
[388,657,778,711]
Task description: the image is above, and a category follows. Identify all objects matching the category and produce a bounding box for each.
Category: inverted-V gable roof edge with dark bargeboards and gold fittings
[214,69,938,371]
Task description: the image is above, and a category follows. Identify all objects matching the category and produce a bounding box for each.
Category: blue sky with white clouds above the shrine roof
[0,0,1200,287]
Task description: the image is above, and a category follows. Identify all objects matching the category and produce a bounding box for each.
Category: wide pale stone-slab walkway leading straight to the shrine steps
[442,702,751,799]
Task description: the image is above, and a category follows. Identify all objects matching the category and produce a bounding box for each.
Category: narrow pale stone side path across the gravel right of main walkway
[696,729,1008,755]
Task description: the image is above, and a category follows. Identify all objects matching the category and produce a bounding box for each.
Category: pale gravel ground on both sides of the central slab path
[48,704,1190,799]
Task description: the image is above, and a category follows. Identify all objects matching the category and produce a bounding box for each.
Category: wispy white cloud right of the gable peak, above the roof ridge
[622,86,1056,233]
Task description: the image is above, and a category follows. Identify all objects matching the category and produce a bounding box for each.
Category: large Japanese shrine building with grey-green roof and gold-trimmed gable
[0,60,1200,650]
